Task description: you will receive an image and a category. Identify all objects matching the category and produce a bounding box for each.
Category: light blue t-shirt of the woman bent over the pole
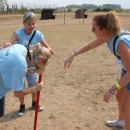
[0,44,27,98]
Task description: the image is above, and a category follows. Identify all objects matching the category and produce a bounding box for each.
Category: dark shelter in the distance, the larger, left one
[40,9,55,20]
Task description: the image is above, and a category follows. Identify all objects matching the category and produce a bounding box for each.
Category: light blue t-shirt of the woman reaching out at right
[105,30,130,70]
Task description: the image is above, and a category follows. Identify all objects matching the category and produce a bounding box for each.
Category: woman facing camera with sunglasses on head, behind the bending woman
[5,12,54,116]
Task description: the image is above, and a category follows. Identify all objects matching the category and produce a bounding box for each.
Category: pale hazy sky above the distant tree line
[8,0,130,9]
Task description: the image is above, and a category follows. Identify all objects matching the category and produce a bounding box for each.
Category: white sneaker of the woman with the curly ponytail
[106,118,125,128]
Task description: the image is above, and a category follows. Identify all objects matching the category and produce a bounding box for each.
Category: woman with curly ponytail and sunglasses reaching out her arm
[64,11,130,130]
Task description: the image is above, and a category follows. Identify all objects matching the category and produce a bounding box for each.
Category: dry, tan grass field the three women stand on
[0,13,130,130]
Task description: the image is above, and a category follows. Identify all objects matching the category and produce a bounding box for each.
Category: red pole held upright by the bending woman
[34,74,42,130]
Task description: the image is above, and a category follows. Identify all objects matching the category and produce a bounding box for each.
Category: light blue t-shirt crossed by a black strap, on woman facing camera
[14,28,44,46]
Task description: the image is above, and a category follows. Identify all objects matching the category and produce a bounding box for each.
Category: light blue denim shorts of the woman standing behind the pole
[26,73,39,88]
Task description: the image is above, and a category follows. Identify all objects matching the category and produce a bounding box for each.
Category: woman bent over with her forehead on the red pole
[0,43,51,117]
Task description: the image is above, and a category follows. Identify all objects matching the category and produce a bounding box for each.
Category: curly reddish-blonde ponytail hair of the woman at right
[93,11,121,35]
